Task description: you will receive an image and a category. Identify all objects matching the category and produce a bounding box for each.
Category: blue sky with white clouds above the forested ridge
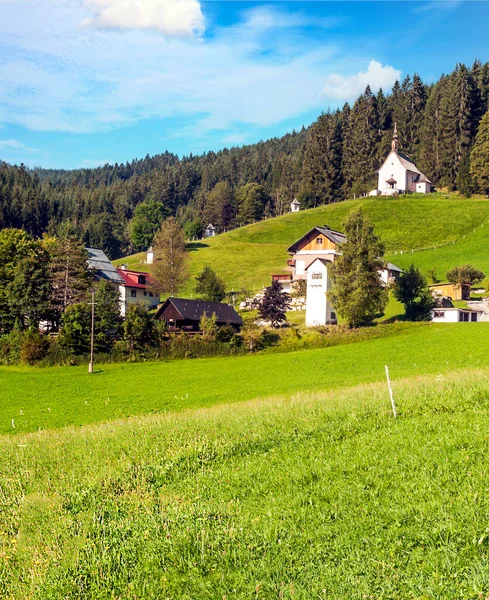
[0,0,489,169]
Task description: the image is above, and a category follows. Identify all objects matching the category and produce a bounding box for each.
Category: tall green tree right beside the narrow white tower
[331,209,388,327]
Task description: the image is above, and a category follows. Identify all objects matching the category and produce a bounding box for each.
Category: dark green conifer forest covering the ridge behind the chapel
[0,61,489,258]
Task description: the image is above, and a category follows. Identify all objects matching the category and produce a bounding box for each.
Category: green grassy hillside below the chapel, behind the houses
[116,194,489,294]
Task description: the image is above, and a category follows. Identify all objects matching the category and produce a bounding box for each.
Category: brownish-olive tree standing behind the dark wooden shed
[152,217,188,297]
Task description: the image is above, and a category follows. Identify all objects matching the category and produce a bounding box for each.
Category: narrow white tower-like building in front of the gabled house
[306,258,336,327]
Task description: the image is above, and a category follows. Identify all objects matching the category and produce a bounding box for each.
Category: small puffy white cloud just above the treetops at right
[323,60,401,100]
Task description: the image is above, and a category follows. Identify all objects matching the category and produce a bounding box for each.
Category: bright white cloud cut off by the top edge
[82,0,204,36]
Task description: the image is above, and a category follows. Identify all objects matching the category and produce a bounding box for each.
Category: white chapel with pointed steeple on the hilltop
[369,124,432,196]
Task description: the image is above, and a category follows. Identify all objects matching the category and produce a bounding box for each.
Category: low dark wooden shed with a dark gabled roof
[154,298,243,333]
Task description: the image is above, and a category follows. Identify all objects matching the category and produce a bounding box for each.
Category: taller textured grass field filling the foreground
[0,368,489,600]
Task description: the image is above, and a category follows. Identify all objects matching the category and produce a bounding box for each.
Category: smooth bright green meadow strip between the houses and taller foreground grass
[0,323,489,433]
